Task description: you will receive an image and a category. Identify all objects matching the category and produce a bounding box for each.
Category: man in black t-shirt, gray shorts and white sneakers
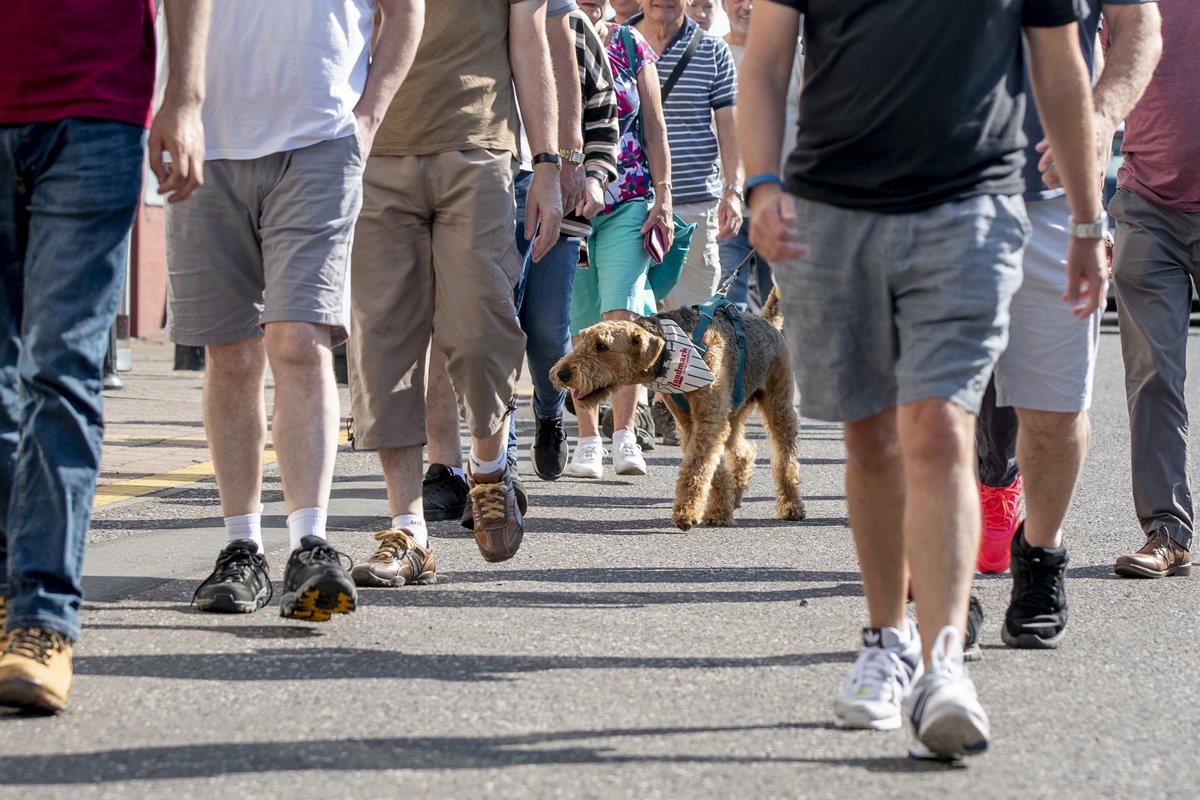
[739,0,1105,758]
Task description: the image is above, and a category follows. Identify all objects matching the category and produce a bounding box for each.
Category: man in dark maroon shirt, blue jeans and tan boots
[0,0,210,712]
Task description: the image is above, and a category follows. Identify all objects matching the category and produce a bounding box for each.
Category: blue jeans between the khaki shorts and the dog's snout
[509,170,580,458]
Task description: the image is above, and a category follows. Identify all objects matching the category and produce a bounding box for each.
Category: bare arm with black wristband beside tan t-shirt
[509,0,559,261]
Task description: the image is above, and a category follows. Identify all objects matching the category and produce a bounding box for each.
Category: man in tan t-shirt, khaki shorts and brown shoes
[349,0,562,585]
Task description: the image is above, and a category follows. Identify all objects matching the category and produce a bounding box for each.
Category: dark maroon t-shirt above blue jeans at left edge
[0,0,155,126]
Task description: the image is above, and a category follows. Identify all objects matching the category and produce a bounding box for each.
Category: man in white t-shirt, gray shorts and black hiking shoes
[167,0,424,620]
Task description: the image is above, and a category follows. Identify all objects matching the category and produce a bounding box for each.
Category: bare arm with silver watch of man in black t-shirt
[1025,24,1108,319]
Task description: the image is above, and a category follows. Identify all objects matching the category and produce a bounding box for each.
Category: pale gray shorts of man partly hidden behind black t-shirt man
[996,191,1104,414]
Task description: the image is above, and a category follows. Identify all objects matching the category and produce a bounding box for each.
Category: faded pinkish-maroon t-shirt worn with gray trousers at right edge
[1117,0,1200,212]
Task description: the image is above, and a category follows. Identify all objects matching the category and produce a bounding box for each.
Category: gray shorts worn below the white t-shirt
[167,136,365,345]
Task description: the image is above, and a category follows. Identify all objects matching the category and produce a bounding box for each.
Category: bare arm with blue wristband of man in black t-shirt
[738,2,806,264]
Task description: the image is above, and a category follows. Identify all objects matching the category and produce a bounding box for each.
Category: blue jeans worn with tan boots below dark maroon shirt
[0,119,145,639]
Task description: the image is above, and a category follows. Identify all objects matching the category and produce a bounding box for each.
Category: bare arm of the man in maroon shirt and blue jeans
[149,0,211,203]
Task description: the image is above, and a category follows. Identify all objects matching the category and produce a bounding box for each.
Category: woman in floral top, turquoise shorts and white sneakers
[566,1,674,477]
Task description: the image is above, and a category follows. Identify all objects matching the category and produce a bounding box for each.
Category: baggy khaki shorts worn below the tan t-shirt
[348,150,526,450]
